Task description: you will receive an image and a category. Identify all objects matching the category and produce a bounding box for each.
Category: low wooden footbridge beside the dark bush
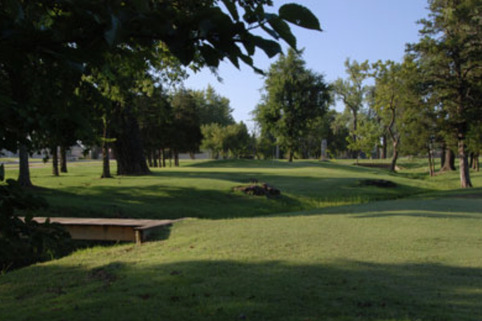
[33,217,179,244]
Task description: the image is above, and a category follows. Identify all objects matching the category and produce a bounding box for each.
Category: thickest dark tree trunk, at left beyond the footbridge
[114,104,151,175]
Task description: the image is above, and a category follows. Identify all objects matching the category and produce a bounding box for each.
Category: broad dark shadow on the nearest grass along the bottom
[0,253,482,321]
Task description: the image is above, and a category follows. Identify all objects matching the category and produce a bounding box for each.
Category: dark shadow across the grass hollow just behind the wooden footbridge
[37,185,303,219]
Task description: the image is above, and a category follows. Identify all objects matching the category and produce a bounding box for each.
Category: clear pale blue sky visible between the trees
[184,0,428,128]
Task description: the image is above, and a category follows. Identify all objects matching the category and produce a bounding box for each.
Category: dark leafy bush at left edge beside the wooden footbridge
[0,180,70,273]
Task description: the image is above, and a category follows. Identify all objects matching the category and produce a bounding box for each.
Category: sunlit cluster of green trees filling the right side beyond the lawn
[254,0,482,188]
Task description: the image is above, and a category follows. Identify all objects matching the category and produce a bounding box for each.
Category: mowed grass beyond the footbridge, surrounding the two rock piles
[3,161,482,219]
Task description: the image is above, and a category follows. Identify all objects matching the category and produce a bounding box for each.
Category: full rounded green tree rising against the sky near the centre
[254,49,331,162]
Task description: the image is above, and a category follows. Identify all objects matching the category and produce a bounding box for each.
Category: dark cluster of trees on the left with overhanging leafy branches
[0,0,321,186]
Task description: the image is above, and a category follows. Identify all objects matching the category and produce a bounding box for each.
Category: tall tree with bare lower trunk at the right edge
[411,0,482,188]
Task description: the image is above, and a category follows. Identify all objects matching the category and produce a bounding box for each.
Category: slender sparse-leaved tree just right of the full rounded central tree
[333,59,370,158]
